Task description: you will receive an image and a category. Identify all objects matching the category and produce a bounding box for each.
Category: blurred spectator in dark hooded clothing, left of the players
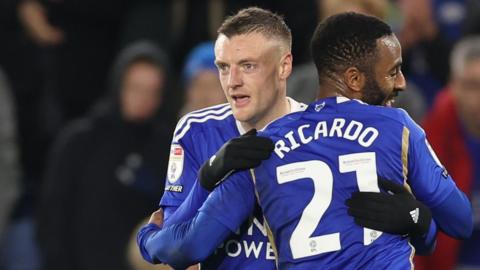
[39,42,172,270]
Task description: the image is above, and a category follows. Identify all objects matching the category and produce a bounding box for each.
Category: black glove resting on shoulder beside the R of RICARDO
[199,129,273,191]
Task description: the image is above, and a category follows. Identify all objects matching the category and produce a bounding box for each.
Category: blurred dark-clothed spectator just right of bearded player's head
[394,0,458,105]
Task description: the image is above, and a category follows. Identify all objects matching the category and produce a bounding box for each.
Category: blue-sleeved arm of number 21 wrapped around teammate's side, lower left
[138,171,255,268]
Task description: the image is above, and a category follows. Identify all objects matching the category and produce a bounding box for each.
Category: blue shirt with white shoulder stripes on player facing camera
[160,98,306,269]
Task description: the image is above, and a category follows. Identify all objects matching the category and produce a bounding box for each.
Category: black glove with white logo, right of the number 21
[346,178,432,237]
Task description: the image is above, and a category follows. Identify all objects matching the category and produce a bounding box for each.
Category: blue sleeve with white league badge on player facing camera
[159,121,201,212]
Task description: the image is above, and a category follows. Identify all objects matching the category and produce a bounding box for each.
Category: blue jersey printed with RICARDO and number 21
[200,97,455,269]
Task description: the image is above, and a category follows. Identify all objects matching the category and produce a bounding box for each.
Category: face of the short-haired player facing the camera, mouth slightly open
[215,32,292,128]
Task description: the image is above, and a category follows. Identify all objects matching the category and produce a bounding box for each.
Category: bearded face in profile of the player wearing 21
[362,35,406,107]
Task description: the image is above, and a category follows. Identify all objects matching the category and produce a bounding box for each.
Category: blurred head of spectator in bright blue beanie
[181,42,227,115]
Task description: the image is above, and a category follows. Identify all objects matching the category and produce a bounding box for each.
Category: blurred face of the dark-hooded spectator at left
[120,62,164,122]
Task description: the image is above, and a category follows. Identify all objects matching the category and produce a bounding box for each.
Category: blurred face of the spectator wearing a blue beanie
[186,69,225,111]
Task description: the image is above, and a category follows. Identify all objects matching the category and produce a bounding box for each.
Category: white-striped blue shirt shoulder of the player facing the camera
[173,103,235,142]
